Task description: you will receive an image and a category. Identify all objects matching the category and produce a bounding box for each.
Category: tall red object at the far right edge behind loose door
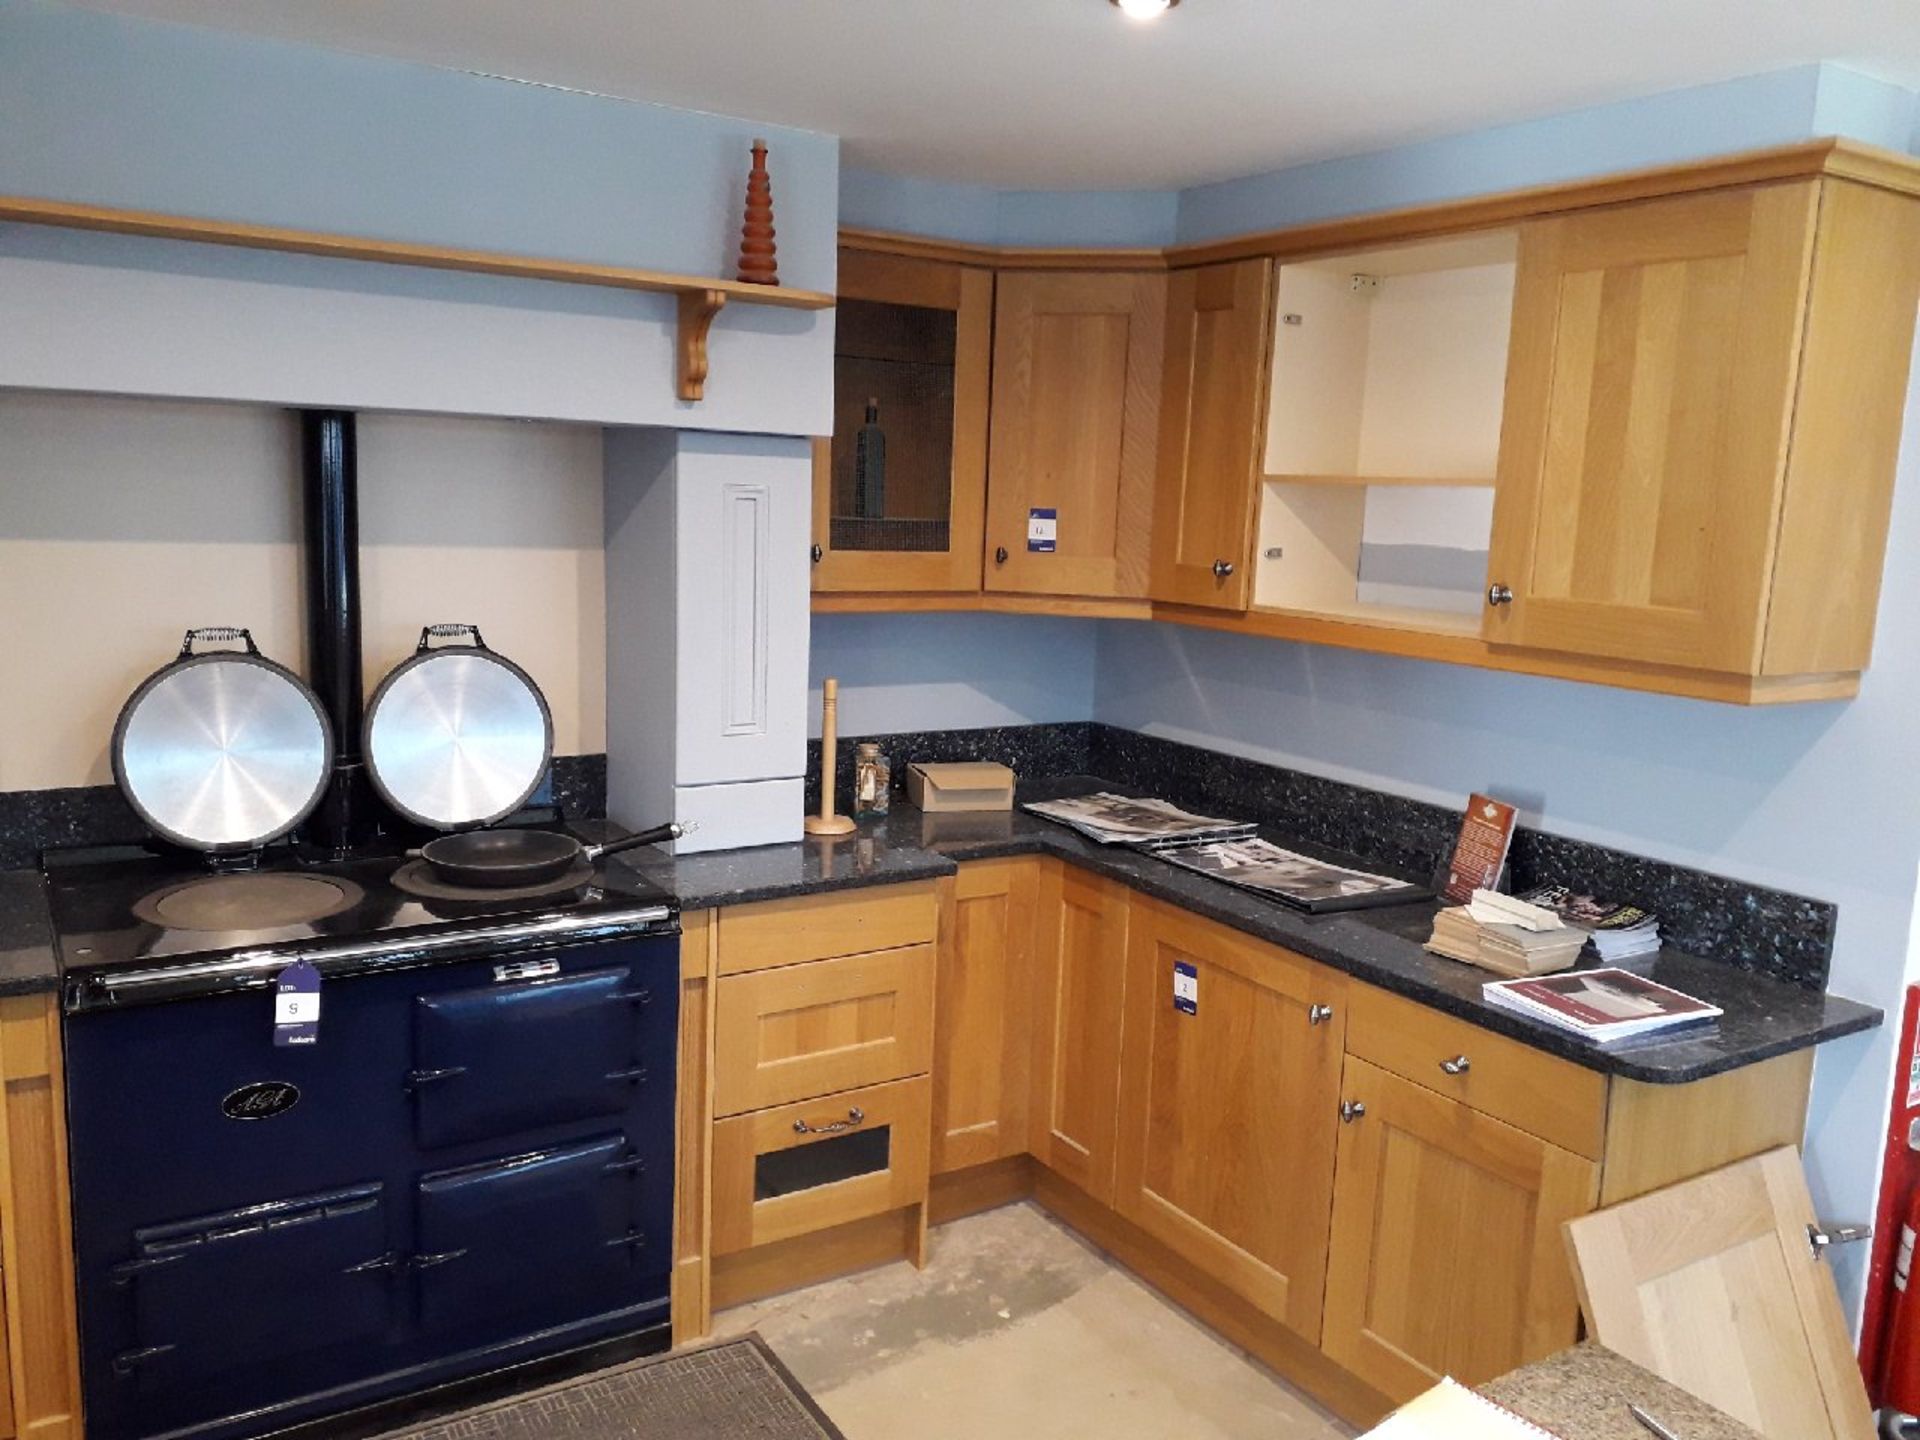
[1860,985,1920,1415]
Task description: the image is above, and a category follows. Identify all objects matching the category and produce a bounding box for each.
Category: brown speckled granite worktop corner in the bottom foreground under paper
[1478,1342,1761,1440]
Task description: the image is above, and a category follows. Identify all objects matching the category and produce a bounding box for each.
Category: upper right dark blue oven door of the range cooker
[407,962,670,1150]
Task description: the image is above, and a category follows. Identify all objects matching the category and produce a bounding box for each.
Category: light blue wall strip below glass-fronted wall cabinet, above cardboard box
[806,614,1098,735]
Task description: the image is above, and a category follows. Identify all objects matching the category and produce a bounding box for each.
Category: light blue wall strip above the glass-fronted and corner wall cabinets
[841,165,1179,246]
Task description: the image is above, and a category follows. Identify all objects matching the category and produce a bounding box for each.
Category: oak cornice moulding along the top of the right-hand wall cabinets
[1165,138,1920,269]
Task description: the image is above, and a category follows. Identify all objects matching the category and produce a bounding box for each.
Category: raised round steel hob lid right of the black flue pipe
[367,624,553,829]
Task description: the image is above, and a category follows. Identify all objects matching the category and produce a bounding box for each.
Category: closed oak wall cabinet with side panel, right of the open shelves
[1486,179,1920,684]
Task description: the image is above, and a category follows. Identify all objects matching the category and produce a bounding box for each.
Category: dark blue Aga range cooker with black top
[48,851,680,1440]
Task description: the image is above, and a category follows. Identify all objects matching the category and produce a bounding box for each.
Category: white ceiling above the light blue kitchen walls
[60,0,1920,190]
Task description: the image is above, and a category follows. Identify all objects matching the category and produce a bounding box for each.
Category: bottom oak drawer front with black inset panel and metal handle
[712,1075,933,1256]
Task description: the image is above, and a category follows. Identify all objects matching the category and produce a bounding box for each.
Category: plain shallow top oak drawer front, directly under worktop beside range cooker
[714,881,939,975]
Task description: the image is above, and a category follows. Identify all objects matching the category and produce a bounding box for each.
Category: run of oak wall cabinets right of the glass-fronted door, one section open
[816,140,1920,705]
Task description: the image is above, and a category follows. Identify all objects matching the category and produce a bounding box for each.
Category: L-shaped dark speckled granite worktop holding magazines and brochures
[614,776,1882,1085]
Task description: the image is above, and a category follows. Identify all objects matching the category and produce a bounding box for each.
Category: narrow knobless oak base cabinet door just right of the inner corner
[1027,860,1127,1204]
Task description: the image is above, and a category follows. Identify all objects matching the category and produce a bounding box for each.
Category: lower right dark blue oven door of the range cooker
[413,1135,672,1346]
